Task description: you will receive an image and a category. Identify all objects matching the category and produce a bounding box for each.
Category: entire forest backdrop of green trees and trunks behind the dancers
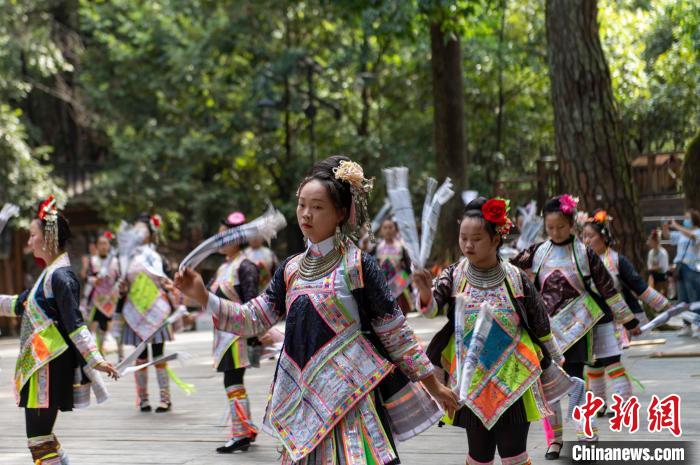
[0,0,700,263]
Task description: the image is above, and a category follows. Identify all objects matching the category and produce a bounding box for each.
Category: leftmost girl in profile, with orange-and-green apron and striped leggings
[0,196,119,465]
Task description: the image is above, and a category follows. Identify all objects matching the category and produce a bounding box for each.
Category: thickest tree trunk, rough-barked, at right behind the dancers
[545,0,644,269]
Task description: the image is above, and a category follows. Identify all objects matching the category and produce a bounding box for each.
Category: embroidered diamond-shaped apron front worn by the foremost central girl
[265,243,393,461]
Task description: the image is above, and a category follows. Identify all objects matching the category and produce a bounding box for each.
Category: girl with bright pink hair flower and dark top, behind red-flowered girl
[512,194,639,460]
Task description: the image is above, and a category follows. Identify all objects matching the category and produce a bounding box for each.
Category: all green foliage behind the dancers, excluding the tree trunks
[0,0,700,236]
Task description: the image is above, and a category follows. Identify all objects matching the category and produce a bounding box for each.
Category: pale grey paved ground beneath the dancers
[0,315,700,465]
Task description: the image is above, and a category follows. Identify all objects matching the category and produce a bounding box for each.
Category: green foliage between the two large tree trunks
[463,0,554,193]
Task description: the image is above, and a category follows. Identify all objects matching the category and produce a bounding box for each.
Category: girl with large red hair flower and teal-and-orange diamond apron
[413,197,566,465]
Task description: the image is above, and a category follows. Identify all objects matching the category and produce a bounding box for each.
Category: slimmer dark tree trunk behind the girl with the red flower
[430,23,468,261]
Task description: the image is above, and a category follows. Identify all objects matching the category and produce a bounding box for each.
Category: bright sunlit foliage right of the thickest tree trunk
[600,0,700,153]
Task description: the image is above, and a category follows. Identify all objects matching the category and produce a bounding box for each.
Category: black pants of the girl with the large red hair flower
[467,416,530,462]
